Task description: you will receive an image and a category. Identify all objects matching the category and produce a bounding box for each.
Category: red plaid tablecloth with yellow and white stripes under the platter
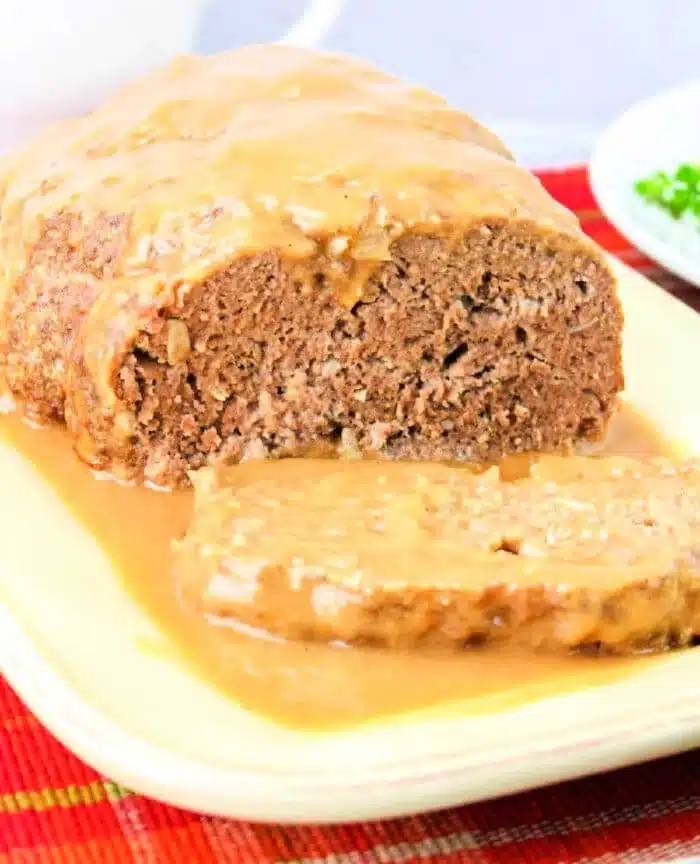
[0,169,700,864]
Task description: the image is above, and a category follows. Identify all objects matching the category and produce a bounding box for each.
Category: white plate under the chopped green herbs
[590,81,700,286]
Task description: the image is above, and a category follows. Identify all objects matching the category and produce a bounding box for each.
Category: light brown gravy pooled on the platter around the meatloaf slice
[0,406,671,729]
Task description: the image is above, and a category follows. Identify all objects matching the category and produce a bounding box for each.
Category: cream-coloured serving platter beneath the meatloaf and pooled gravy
[0,258,700,822]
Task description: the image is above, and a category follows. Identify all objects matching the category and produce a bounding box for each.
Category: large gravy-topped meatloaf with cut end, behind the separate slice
[0,46,622,486]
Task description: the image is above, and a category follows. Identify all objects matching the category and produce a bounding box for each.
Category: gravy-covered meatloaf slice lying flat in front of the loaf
[174,457,700,653]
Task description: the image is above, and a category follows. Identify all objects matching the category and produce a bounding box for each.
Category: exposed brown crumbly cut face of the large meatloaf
[112,225,622,485]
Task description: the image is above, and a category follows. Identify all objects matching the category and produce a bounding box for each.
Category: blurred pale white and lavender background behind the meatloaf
[0,0,700,165]
